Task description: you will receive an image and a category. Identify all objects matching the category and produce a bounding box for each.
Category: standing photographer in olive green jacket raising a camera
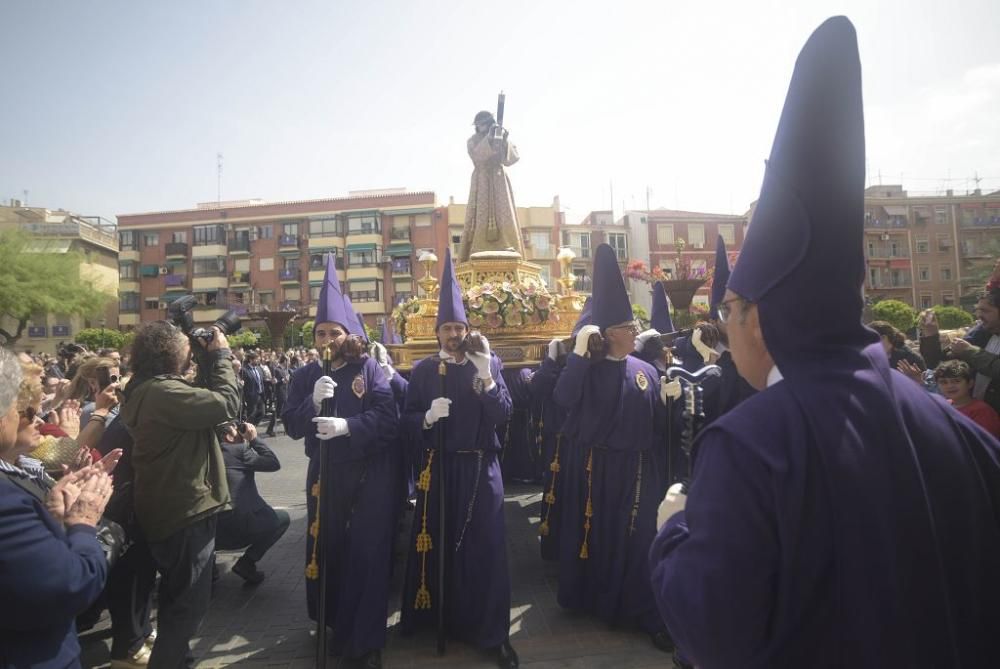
[120,321,240,669]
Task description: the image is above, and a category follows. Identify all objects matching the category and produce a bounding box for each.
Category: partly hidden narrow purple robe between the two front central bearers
[529,358,566,561]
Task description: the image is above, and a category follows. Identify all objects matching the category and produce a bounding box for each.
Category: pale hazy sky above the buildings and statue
[0,0,1000,222]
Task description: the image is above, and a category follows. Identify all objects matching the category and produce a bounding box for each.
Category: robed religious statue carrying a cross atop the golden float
[458,93,524,262]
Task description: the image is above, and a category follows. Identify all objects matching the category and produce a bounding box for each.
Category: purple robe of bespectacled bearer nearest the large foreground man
[553,353,666,634]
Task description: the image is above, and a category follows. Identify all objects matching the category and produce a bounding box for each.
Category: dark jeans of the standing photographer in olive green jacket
[149,516,217,669]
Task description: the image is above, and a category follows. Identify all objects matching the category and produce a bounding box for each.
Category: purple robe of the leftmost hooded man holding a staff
[282,357,400,657]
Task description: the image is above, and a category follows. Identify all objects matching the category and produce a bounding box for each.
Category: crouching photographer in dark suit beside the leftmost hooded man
[215,423,291,585]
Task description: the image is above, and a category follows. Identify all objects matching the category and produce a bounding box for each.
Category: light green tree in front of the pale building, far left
[0,229,114,344]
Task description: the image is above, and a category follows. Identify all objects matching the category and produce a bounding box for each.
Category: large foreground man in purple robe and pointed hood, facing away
[650,17,1000,669]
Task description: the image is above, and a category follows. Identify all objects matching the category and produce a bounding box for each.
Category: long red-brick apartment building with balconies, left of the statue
[118,189,443,336]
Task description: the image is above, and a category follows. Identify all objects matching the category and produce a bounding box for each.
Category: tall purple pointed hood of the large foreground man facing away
[729,17,877,378]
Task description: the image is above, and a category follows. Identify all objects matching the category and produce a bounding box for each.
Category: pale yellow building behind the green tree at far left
[0,201,119,353]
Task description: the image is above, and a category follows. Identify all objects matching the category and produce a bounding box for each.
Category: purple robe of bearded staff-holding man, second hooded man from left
[401,355,511,649]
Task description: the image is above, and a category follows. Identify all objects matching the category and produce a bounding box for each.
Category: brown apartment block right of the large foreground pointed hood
[864,185,1000,309]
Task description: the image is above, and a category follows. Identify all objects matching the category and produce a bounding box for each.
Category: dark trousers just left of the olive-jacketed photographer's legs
[106,536,156,660]
